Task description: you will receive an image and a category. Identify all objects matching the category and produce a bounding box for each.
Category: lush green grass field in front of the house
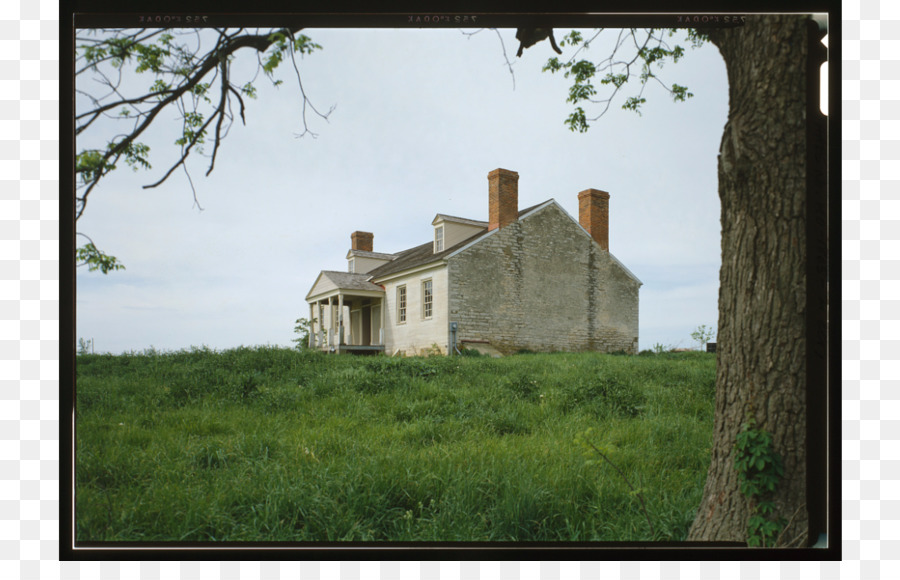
[75,347,715,542]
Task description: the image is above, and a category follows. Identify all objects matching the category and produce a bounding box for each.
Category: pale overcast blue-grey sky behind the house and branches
[76,29,728,353]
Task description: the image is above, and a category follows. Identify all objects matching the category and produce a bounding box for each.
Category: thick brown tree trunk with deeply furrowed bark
[688,16,824,547]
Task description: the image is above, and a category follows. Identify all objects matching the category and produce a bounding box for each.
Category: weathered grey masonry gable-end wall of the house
[448,204,640,354]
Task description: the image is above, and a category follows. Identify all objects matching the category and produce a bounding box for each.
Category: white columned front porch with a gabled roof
[306,272,385,354]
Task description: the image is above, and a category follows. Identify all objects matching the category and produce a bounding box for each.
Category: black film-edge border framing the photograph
[59,0,841,561]
